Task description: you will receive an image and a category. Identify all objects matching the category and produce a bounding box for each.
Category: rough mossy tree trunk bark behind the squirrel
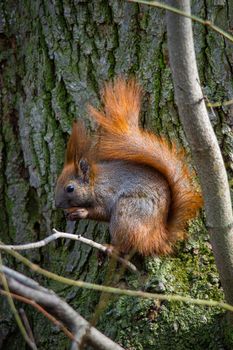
[0,0,233,350]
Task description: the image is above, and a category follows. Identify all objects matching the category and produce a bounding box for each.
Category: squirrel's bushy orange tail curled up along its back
[89,78,202,250]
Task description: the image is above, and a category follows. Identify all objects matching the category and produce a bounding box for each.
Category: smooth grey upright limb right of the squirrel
[167,0,233,304]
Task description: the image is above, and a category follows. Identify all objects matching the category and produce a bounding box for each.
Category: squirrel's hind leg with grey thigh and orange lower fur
[110,194,171,255]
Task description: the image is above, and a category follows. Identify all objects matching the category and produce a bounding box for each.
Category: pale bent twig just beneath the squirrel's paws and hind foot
[0,228,137,272]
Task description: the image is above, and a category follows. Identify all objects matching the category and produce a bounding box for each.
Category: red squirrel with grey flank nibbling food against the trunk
[55,78,202,255]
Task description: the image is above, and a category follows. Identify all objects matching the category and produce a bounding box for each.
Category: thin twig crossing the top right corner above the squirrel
[128,0,233,42]
